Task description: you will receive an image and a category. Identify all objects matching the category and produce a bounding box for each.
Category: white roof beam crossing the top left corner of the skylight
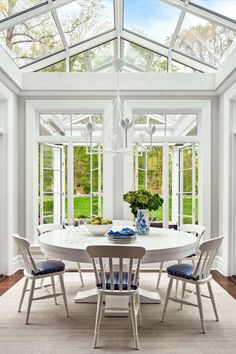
[0,0,74,31]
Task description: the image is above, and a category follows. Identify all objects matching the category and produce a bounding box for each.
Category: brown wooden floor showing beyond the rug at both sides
[0,270,236,299]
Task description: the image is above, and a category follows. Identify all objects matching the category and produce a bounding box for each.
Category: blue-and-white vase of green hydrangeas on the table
[123,189,163,235]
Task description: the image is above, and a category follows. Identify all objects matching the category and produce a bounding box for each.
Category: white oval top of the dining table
[39,227,197,260]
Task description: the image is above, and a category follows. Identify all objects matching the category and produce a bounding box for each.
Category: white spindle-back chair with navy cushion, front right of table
[162,236,223,333]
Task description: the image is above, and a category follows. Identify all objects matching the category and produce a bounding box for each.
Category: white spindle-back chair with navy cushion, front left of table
[13,234,69,324]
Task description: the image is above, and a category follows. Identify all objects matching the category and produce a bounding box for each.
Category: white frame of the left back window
[25,100,113,244]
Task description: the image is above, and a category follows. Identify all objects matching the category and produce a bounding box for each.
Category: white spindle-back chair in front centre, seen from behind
[86,245,146,349]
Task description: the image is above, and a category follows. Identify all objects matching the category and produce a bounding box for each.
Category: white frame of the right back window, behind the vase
[123,99,211,236]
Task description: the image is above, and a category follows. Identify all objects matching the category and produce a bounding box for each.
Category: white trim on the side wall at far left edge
[0,82,18,274]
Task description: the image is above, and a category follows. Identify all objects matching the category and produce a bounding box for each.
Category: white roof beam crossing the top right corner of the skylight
[161,0,236,31]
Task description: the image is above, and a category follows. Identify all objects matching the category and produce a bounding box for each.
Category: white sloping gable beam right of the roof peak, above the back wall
[121,30,215,72]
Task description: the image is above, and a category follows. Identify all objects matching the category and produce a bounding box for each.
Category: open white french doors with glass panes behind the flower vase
[134,143,198,227]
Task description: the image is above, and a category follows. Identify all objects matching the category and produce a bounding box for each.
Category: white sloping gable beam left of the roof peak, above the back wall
[21,31,116,72]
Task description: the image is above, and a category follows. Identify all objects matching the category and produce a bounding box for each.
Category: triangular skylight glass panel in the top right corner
[191,0,236,20]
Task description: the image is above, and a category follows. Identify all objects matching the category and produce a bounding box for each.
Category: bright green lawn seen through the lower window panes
[44,196,198,223]
